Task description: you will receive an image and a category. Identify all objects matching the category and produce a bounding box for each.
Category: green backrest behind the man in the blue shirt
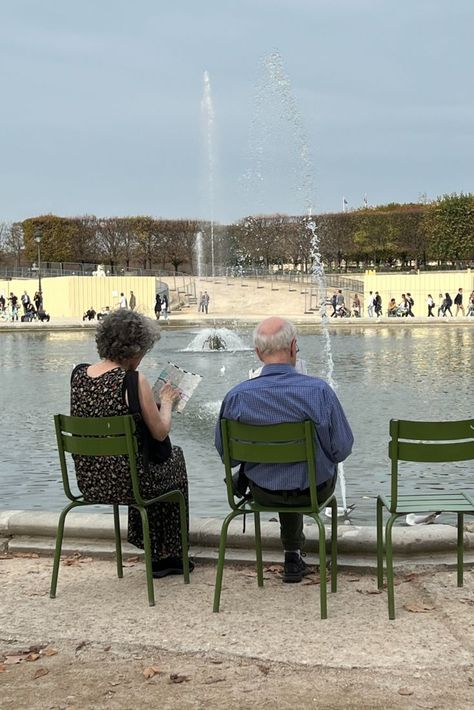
[221,419,319,512]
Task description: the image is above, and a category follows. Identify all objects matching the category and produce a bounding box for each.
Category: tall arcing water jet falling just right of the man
[248,52,348,511]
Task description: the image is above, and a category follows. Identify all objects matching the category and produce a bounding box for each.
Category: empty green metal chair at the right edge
[377,419,474,619]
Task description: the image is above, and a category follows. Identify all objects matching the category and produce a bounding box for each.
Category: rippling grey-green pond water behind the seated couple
[0,324,474,524]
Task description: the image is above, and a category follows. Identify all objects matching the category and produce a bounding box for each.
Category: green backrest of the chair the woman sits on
[54,414,143,505]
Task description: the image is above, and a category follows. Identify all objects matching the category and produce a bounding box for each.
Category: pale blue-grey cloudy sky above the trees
[0,0,474,222]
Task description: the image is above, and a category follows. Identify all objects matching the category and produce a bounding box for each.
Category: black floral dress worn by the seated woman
[71,365,188,560]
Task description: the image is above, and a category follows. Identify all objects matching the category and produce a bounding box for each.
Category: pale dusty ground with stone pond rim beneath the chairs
[0,511,474,710]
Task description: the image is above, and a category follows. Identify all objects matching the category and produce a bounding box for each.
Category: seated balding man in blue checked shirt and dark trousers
[215,317,354,582]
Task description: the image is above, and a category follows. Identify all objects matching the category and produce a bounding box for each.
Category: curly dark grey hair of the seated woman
[95,308,161,364]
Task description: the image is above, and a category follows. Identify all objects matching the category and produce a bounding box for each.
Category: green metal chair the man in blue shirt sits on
[213,419,337,619]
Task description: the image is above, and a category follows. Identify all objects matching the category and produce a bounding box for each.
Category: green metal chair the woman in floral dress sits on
[50,414,189,606]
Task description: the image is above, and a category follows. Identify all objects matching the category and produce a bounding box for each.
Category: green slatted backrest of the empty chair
[388,419,474,512]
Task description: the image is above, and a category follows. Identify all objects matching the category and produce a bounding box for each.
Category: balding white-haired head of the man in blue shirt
[253,316,296,365]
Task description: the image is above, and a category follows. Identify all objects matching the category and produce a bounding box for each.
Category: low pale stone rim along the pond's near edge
[0,510,474,556]
